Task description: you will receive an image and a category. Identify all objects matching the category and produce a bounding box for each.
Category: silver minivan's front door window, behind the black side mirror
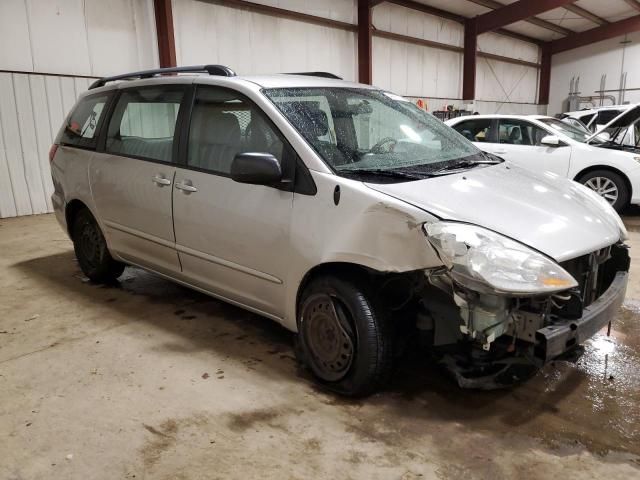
[187,87,285,175]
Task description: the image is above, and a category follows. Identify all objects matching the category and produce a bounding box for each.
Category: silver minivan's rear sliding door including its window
[89,86,185,274]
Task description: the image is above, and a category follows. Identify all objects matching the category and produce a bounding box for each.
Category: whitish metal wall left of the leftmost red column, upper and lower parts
[0,0,158,218]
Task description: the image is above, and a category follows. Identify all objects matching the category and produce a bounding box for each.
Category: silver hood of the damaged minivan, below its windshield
[366,162,620,262]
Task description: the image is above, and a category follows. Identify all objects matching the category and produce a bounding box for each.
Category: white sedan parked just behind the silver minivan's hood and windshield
[446,115,640,211]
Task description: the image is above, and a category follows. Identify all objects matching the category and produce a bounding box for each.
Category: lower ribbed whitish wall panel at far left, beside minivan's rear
[0,73,90,218]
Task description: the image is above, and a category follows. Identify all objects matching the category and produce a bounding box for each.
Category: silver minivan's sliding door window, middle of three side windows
[106,87,184,162]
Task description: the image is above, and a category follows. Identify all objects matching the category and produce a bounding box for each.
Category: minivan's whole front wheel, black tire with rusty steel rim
[296,275,394,397]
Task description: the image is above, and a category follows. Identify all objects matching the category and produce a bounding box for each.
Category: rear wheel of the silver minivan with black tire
[71,209,125,283]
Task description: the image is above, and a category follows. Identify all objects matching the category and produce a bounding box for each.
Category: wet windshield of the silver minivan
[264,87,481,178]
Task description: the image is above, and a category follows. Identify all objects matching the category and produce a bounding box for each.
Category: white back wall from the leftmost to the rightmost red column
[172,0,544,113]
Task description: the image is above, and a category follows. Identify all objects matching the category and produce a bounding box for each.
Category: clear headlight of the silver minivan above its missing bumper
[424,222,578,296]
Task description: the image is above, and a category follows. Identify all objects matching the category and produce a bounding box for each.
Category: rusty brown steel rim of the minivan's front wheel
[302,294,355,382]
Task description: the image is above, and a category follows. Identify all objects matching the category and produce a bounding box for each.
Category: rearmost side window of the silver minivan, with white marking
[59,94,109,148]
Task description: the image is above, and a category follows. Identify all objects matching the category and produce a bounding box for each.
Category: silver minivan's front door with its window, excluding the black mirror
[173,86,293,318]
